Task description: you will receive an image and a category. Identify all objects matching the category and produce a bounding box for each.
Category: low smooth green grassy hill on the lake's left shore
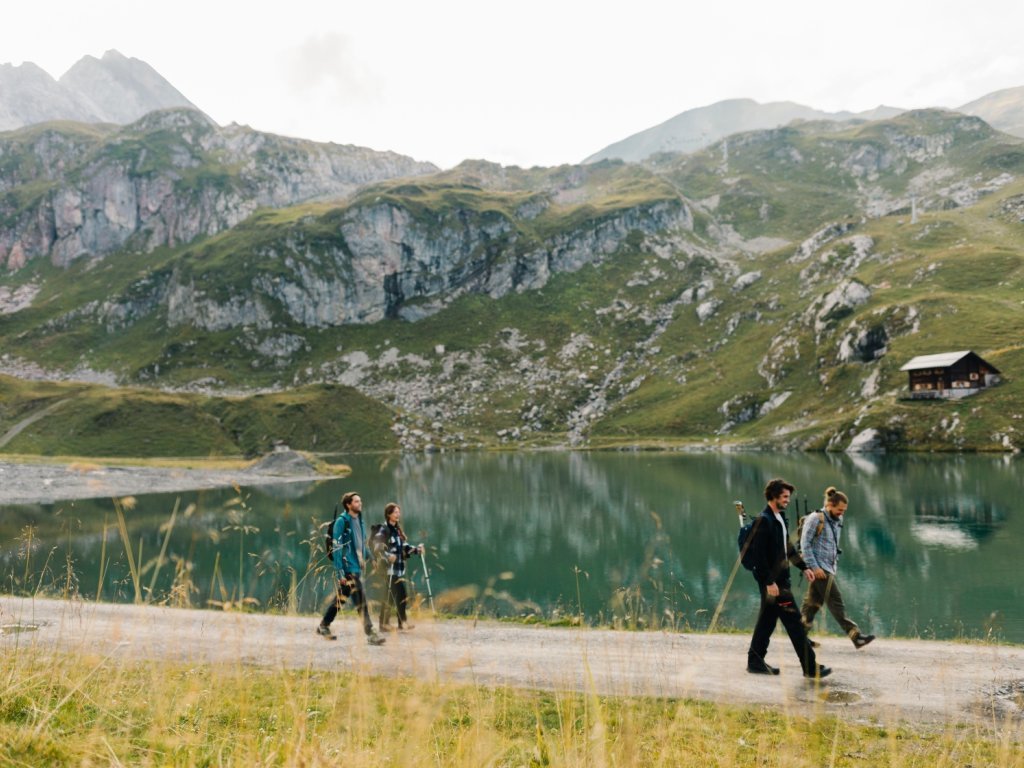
[0,376,395,458]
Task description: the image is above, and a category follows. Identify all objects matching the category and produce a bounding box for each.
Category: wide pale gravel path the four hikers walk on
[0,596,1024,736]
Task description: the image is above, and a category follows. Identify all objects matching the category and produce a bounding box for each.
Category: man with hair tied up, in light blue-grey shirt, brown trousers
[800,486,874,649]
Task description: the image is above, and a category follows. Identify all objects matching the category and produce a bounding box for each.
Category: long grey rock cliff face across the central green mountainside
[108,193,692,331]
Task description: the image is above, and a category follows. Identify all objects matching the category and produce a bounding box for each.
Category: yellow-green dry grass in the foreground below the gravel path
[0,640,1024,768]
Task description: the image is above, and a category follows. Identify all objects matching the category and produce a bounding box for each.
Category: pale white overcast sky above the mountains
[0,0,1024,168]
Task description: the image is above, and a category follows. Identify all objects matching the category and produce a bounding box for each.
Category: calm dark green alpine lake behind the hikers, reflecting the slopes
[0,452,1024,643]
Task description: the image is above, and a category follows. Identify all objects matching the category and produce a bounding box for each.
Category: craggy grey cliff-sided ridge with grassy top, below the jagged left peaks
[0,110,436,269]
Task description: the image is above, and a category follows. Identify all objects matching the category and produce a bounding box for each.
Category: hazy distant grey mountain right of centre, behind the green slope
[583,98,903,163]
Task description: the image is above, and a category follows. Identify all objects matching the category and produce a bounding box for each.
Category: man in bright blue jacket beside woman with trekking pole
[316,490,384,645]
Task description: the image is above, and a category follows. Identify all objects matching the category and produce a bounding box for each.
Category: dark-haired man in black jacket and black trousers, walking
[746,478,831,678]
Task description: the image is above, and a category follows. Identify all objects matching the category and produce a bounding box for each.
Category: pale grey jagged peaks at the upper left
[0,50,197,131]
